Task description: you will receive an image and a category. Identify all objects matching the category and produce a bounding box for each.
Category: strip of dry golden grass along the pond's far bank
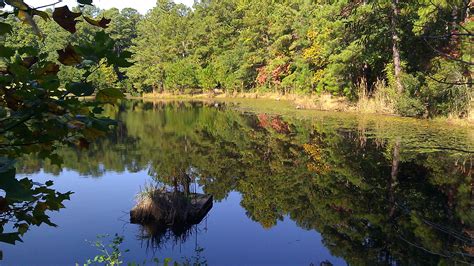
[126,93,474,128]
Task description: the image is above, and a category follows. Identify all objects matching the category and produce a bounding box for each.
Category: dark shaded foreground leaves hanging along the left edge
[0,0,128,244]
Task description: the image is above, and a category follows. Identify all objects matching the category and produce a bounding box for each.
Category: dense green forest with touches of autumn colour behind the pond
[1,0,474,117]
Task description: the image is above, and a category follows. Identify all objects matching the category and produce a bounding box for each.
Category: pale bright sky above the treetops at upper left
[25,0,194,14]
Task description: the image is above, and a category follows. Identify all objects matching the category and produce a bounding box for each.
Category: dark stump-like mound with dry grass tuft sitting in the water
[130,191,213,227]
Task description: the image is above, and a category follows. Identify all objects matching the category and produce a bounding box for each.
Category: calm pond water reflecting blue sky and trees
[0,101,474,265]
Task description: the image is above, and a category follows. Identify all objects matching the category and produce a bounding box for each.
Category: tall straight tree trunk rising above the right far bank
[391,0,403,94]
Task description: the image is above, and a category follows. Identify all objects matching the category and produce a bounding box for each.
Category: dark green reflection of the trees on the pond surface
[7,101,474,265]
